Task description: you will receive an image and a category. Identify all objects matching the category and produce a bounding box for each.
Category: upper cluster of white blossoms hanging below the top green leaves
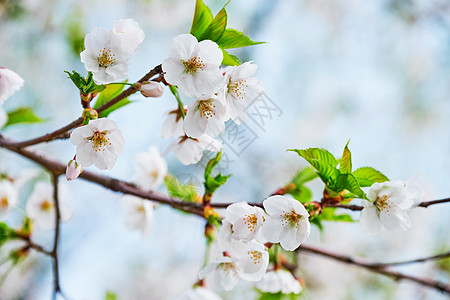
[162,34,264,165]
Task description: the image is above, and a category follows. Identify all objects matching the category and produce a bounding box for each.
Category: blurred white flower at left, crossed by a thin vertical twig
[26,181,73,230]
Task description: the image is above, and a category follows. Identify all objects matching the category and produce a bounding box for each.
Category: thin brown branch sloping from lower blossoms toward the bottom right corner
[297,245,450,295]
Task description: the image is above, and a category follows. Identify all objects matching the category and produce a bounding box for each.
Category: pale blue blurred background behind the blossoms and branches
[0,0,450,300]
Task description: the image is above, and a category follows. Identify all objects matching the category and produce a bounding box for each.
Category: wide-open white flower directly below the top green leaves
[162,34,224,97]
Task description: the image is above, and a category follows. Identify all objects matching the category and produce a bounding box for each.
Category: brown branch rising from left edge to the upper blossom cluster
[11,65,162,148]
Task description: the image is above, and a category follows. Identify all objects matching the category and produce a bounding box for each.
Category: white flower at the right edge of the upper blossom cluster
[225,62,264,124]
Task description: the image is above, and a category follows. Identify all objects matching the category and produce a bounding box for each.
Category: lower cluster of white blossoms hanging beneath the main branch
[199,196,311,294]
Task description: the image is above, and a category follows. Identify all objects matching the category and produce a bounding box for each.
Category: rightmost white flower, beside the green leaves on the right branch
[360,180,417,234]
